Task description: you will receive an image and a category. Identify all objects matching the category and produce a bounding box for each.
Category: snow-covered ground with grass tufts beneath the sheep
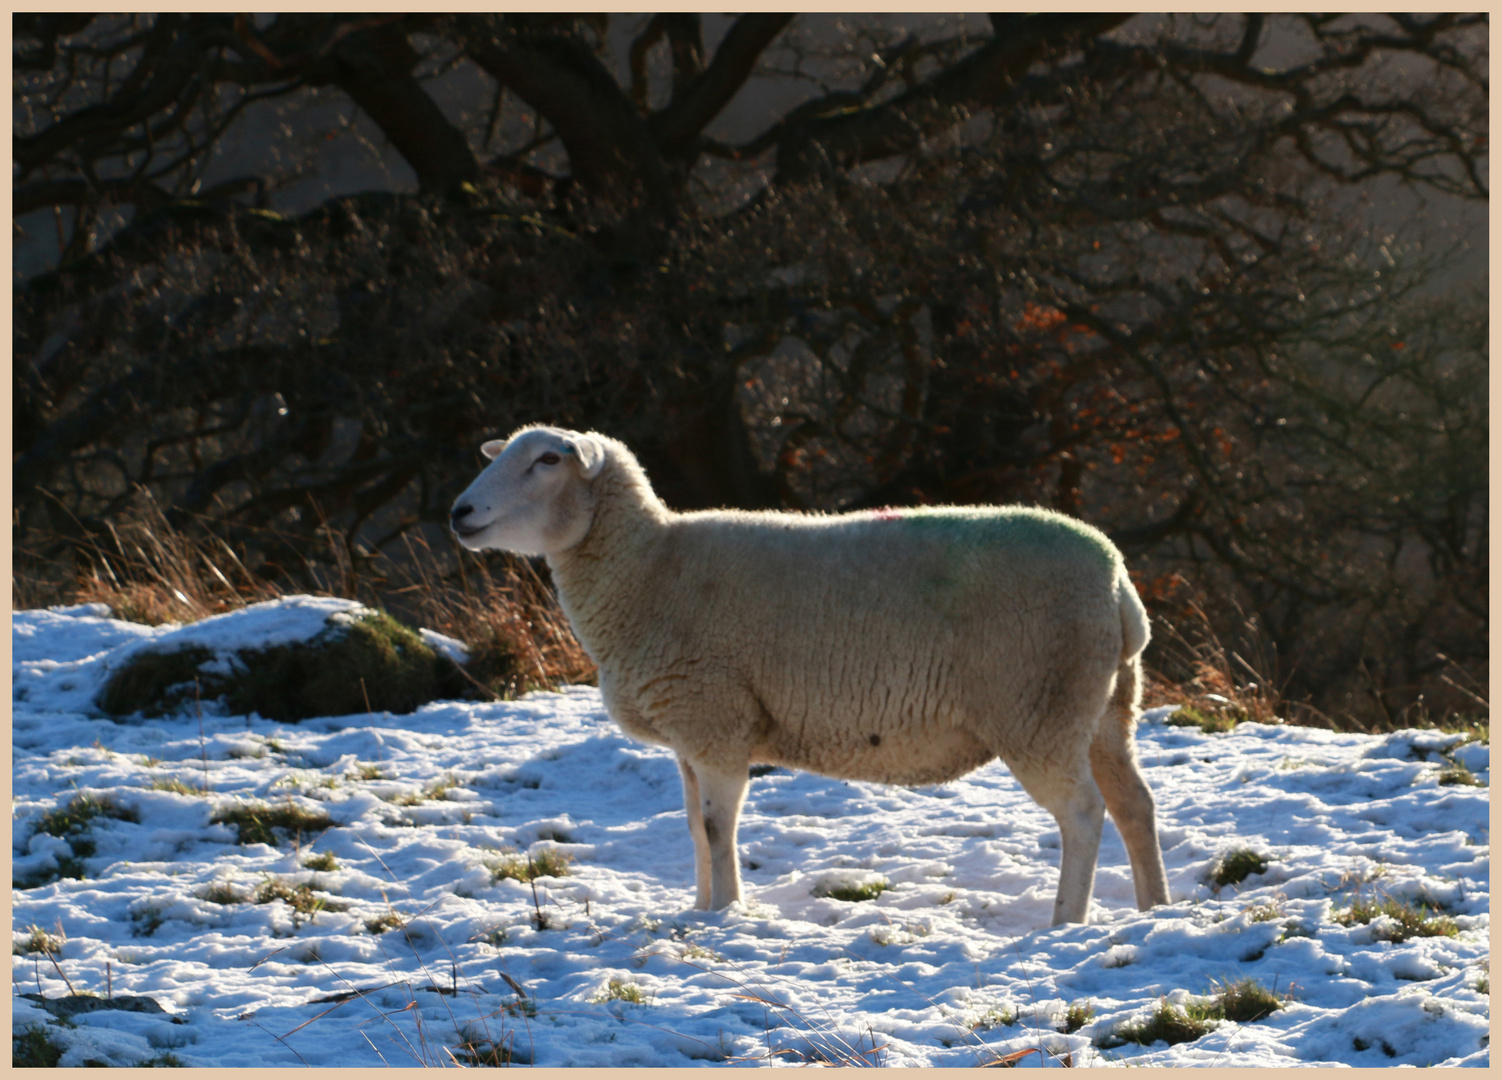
[12,601,1490,1066]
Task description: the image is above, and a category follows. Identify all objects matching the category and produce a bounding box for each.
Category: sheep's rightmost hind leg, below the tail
[1090,661,1169,912]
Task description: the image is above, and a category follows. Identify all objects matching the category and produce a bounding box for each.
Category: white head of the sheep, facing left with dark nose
[449,428,607,554]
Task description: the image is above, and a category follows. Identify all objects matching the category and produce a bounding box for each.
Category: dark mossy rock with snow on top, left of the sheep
[98,611,464,723]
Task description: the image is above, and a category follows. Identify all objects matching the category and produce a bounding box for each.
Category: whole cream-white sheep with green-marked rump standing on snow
[451,425,1169,924]
